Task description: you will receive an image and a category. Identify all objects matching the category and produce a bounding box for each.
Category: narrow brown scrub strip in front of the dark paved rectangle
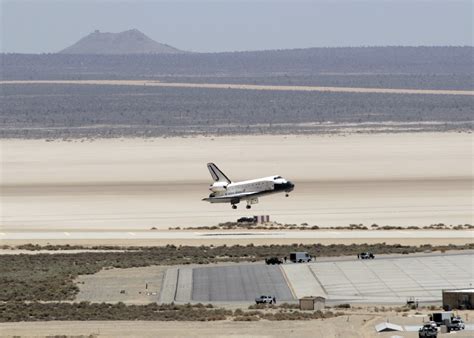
[0,302,340,322]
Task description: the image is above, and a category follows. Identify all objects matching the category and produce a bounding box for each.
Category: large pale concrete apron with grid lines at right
[311,254,474,303]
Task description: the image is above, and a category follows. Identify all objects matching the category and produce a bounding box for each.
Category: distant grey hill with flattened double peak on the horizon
[59,29,183,55]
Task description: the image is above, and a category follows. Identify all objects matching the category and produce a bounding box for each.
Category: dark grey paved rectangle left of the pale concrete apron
[192,264,294,303]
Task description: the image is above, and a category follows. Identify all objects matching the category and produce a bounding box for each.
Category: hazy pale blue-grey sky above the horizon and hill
[0,0,473,53]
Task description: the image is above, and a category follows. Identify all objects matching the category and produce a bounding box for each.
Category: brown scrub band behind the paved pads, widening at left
[0,243,474,301]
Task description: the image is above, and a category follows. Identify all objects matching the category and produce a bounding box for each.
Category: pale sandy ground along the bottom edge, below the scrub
[0,309,472,338]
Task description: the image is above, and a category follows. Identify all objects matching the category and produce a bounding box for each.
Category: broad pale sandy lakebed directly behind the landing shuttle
[0,133,473,235]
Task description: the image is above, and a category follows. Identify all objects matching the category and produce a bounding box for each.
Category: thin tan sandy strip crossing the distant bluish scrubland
[0,80,474,96]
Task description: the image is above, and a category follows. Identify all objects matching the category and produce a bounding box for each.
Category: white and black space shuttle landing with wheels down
[202,163,295,209]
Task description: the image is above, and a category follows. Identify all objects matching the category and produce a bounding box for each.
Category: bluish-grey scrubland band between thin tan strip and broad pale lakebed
[0,84,472,141]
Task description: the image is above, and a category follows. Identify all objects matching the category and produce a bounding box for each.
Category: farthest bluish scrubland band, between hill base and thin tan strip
[0,46,473,81]
